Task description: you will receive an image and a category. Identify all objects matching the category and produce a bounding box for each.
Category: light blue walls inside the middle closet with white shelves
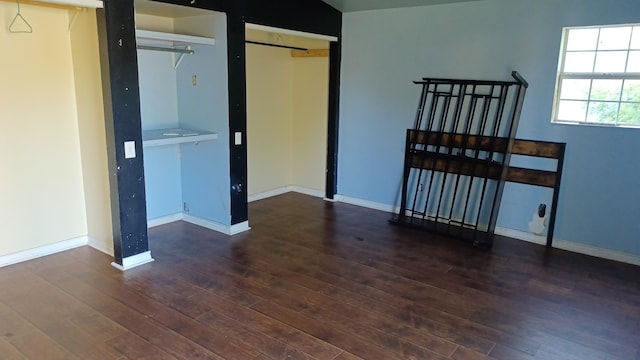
[138,14,231,225]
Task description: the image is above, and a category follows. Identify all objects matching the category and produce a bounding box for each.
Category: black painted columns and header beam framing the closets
[98,0,342,264]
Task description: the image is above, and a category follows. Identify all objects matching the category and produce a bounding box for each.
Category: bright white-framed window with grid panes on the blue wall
[552,24,640,127]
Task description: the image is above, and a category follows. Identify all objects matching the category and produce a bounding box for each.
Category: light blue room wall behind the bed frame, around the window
[338,0,640,255]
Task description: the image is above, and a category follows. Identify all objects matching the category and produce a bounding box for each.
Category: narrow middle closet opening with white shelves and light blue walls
[135,0,236,234]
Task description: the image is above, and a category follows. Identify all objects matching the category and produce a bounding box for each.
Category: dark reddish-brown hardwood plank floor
[0,193,640,360]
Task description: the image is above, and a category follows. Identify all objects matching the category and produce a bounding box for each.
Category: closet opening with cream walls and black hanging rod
[245,24,337,202]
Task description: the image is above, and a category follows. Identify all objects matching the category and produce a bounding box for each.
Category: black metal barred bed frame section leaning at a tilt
[391,71,528,248]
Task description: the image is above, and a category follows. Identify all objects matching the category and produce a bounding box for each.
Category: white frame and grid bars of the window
[551,24,640,128]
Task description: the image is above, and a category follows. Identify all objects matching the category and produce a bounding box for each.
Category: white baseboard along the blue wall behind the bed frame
[334,195,640,266]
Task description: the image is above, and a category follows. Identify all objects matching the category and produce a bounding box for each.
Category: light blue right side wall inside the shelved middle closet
[176,14,231,225]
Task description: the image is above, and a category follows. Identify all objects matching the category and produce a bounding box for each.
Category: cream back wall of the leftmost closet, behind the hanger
[0,2,91,255]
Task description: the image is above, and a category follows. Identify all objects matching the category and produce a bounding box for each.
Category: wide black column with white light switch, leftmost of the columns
[97,0,149,265]
